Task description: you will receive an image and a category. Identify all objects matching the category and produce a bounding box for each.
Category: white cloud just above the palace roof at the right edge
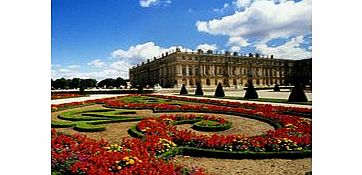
[256,36,312,60]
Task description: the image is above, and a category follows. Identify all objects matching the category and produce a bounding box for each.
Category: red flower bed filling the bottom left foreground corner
[51,130,205,175]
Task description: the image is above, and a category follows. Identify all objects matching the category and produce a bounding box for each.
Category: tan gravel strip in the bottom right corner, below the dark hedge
[172,156,312,175]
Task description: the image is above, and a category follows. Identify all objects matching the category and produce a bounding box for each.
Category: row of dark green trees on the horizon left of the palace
[51,77,127,89]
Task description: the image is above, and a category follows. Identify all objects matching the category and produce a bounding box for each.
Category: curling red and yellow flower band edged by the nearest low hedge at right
[131,111,311,158]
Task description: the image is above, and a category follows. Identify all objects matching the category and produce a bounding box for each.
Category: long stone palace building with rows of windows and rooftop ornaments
[129,48,312,88]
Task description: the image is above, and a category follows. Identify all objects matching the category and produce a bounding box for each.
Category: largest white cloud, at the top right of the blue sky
[196,0,312,42]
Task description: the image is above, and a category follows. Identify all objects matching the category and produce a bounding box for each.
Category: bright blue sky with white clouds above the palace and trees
[51,0,312,80]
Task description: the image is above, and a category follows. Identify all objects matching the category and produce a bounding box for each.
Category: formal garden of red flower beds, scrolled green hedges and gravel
[51,94,312,175]
